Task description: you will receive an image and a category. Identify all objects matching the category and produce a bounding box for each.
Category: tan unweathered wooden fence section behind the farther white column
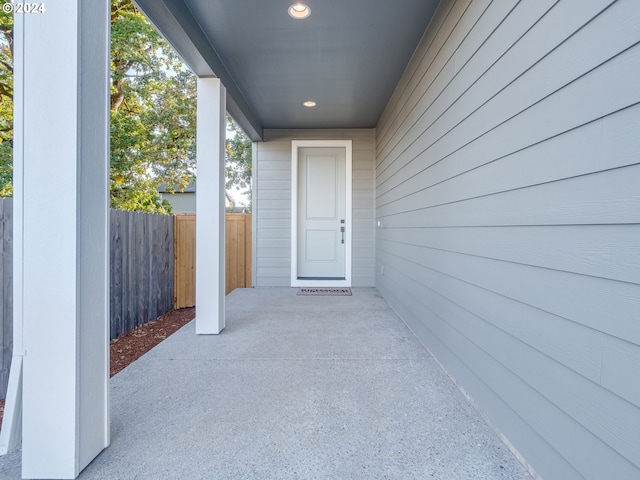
[174,213,251,308]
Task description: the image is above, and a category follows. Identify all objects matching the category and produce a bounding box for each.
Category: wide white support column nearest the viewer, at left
[12,0,110,478]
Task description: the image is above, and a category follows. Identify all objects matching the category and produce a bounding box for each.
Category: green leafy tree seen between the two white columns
[110,0,196,213]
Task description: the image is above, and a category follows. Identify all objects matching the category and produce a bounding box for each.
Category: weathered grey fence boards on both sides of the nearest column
[0,204,173,398]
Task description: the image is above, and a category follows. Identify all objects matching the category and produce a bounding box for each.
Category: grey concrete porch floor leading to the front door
[0,288,531,480]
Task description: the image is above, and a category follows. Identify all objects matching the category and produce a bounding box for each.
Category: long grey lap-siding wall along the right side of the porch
[376,0,640,480]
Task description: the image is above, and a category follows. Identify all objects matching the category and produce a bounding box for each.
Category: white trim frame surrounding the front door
[291,140,353,287]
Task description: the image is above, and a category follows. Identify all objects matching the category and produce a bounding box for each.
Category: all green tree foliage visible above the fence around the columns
[0,0,251,213]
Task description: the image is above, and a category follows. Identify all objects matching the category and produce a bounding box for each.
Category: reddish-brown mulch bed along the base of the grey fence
[0,307,196,432]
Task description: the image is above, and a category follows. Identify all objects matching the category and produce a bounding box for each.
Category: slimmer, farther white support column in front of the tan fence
[196,78,226,334]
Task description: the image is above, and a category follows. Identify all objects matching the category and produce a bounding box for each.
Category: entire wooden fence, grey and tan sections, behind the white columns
[0,206,251,399]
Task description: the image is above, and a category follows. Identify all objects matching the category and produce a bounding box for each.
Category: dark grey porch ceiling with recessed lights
[130,0,439,141]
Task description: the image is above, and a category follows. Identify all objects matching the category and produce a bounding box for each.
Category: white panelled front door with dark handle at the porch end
[292,141,351,286]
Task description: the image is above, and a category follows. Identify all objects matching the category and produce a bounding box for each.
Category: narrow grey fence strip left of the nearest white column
[0,198,13,398]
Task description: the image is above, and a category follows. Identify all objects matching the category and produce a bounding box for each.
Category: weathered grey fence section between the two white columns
[110,210,174,339]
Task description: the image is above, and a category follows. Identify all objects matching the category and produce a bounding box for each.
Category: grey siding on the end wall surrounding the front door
[253,129,375,287]
